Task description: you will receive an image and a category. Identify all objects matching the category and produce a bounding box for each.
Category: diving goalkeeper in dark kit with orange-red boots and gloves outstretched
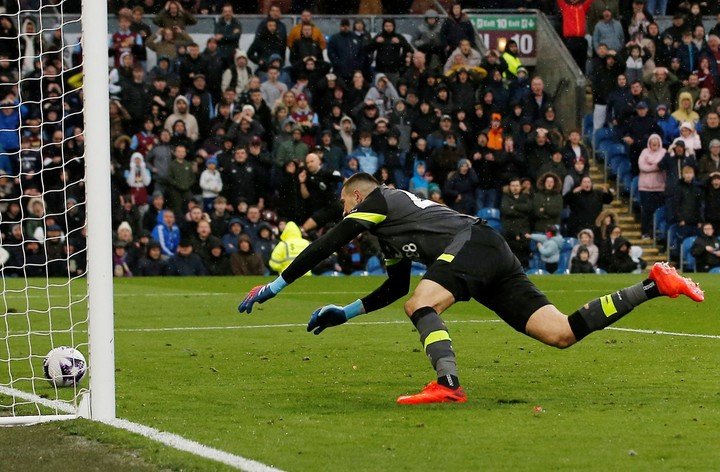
[238,173,704,404]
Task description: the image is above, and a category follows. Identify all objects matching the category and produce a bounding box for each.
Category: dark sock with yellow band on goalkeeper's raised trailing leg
[568,279,660,341]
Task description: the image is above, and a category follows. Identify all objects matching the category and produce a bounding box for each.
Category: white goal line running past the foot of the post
[0,385,282,472]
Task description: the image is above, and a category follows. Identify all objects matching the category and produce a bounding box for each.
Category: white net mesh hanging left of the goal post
[0,0,88,416]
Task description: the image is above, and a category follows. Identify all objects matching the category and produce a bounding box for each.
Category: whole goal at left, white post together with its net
[0,0,115,425]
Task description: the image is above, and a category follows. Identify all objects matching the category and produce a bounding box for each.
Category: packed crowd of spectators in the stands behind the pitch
[0,0,720,277]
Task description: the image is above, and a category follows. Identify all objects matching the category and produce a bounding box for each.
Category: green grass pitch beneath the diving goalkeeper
[0,276,720,471]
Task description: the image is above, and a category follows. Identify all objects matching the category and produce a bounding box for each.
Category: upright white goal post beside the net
[82,0,115,420]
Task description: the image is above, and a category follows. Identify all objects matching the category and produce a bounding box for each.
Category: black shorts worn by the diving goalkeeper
[423,224,550,333]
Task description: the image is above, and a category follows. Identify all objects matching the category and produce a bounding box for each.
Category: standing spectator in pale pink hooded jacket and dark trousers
[638,134,665,239]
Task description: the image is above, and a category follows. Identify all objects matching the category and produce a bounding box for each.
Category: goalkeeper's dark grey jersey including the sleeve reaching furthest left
[282,185,478,283]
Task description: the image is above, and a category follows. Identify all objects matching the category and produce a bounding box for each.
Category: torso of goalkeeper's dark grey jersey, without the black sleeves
[345,186,478,266]
